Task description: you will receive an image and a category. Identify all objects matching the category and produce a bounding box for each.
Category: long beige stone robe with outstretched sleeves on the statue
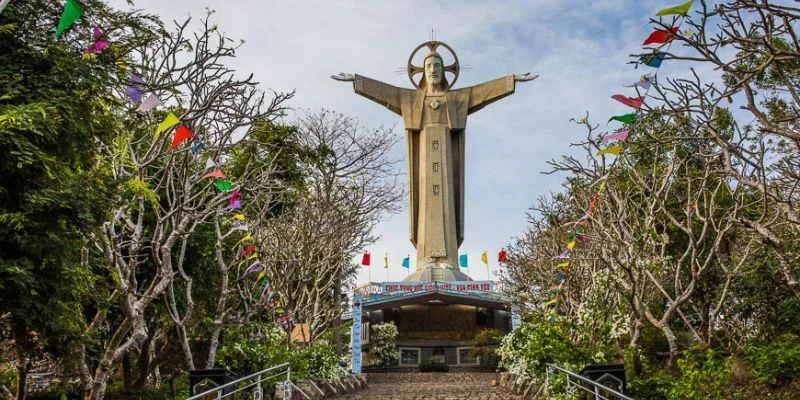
[353,75,514,269]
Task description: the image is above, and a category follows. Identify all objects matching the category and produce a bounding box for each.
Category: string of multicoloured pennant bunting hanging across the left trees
[48,0,289,322]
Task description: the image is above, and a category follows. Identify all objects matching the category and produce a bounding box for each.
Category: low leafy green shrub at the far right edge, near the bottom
[742,334,800,385]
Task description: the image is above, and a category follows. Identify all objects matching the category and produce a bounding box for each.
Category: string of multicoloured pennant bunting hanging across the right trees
[544,0,694,322]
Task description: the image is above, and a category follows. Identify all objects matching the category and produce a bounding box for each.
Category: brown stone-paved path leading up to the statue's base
[340,372,521,400]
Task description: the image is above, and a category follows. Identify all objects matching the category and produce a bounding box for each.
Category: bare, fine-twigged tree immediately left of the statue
[256,110,404,341]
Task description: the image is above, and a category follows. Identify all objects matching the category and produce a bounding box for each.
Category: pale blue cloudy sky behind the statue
[111,0,704,282]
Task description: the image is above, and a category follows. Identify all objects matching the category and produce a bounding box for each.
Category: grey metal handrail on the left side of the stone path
[186,363,298,400]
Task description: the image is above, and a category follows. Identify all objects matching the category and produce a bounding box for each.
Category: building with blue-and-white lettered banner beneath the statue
[357,268,511,367]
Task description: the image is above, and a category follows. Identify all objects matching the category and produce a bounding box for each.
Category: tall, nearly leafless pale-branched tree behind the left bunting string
[80,13,292,399]
